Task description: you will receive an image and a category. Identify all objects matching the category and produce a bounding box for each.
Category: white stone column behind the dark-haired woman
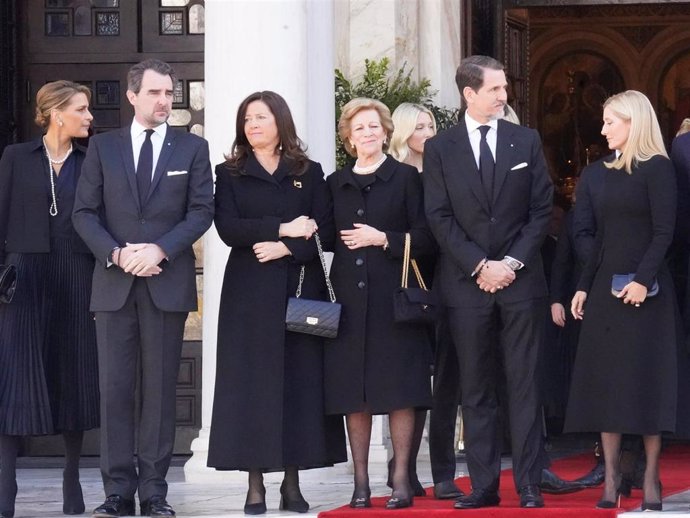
[185,0,335,482]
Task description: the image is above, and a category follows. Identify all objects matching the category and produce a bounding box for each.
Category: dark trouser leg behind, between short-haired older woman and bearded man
[429,314,460,484]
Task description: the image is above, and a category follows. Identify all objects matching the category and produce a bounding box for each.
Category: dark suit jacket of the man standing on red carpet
[422,120,553,307]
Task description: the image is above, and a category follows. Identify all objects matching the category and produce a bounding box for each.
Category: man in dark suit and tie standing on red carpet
[423,56,553,509]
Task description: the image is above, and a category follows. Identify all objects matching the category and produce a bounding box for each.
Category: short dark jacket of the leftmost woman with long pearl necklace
[0,138,90,263]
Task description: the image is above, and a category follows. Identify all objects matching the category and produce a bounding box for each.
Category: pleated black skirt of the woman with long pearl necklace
[0,239,99,436]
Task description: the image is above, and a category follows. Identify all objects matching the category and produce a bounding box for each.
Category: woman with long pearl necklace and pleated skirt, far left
[0,80,99,518]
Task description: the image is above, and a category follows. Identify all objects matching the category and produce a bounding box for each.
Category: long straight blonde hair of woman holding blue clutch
[603,90,668,174]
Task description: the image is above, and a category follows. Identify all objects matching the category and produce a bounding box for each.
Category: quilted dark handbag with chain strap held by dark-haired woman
[285,233,341,338]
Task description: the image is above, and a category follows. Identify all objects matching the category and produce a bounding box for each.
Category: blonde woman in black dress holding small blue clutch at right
[565,90,679,510]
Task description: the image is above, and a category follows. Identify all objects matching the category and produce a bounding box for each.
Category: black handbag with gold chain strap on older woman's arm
[393,233,438,324]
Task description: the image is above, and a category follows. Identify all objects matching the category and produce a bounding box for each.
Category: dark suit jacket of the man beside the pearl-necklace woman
[72,126,213,311]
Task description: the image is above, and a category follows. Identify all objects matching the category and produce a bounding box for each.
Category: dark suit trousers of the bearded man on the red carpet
[448,297,545,490]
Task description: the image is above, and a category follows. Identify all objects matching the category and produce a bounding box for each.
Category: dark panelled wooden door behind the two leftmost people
[17,0,204,455]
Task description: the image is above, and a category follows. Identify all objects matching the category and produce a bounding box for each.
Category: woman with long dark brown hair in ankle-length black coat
[208,91,347,514]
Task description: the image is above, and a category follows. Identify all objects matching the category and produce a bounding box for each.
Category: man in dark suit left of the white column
[72,60,213,517]
